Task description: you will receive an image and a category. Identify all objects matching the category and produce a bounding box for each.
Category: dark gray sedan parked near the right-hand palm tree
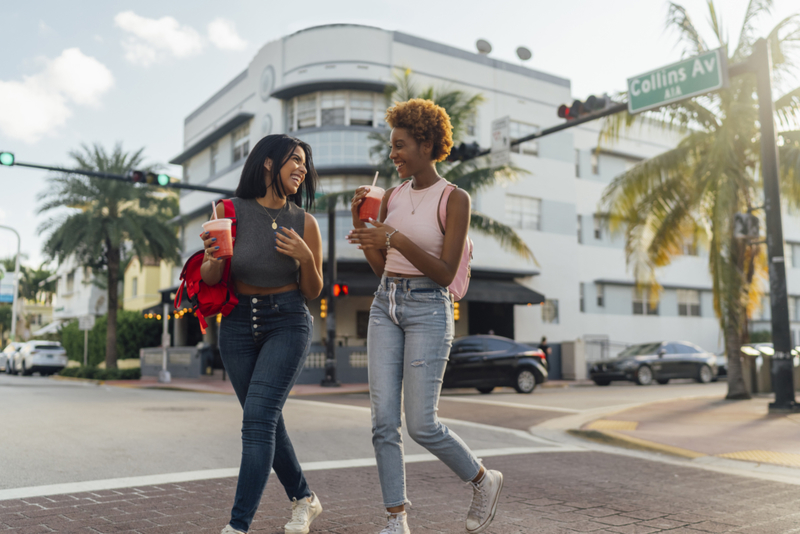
[589,341,717,386]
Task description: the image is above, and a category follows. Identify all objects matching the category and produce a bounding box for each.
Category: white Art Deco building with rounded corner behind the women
[172,25,752,360]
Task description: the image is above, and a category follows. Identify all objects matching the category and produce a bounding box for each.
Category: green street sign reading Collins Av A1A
[628,47,728,114]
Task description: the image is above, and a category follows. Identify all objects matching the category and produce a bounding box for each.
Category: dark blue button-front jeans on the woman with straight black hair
[219,290,312,532]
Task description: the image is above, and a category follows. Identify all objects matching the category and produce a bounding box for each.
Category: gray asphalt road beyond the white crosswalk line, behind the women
[0,375,726,490]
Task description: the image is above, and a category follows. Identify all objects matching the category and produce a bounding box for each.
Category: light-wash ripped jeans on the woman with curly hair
[367,276,481,508]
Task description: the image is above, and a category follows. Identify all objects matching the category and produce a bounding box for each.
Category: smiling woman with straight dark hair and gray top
[200,135,322,534]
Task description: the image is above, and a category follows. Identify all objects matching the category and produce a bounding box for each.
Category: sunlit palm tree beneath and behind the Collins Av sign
[601,0,800,399]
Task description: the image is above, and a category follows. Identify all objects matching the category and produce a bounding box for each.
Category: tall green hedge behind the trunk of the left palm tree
[60,310,161,367]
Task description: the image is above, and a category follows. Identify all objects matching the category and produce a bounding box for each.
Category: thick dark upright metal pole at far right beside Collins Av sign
[750,39,799,412]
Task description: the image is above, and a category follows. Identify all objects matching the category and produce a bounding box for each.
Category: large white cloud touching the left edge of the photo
[0,48,114,143]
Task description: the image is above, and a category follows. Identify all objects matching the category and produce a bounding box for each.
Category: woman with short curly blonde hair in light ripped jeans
[349,99,503,534]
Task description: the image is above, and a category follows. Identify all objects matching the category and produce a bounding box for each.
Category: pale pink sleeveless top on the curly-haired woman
[384,178,448,276]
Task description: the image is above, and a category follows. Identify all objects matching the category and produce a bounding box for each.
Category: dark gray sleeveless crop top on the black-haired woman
[231,198,306,287]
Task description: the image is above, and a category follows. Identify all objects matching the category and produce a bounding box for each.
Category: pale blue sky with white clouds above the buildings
[0,0,800,266]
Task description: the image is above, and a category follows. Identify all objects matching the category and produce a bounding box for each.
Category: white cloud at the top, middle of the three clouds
[114,11,203,67]
